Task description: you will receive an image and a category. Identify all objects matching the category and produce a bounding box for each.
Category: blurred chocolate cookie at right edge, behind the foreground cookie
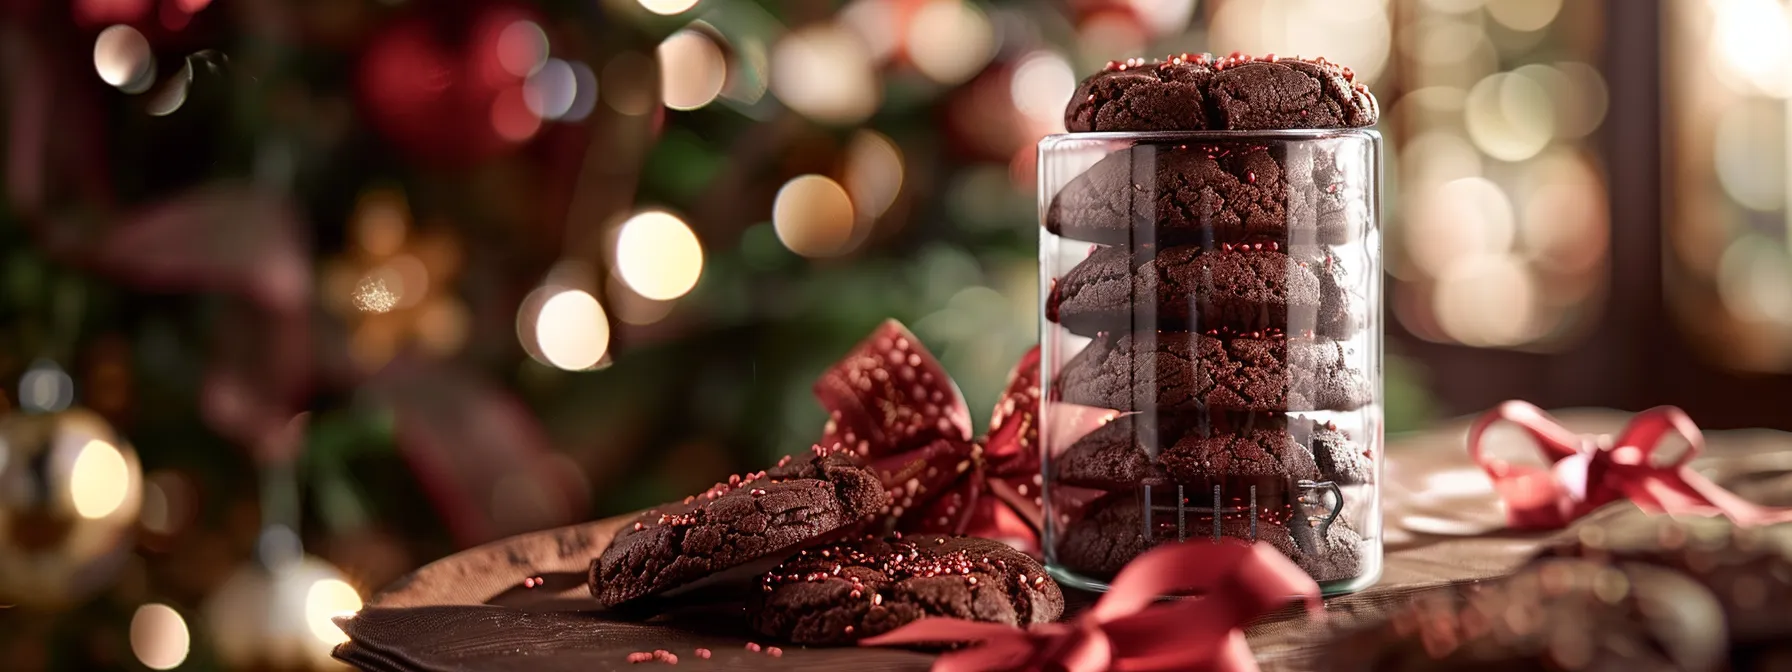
[1545,511,1792,645]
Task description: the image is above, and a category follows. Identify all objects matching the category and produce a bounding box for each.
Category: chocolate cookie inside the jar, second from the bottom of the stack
[1052,414,1374,491]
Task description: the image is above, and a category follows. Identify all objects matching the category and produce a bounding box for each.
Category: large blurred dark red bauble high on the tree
[358,5,541,165]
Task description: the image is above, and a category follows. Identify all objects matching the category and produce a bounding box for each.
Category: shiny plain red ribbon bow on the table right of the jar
[1468,401,1792,530]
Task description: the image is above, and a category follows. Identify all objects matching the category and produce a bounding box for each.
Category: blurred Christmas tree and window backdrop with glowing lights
[0,0,1792,670]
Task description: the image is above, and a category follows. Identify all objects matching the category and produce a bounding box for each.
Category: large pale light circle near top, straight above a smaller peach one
[771,23,882,124]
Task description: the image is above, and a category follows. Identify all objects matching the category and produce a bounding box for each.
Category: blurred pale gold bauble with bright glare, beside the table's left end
[204,556,360,672]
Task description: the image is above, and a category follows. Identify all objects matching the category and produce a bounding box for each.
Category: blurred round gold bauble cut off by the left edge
[0,409,143,609]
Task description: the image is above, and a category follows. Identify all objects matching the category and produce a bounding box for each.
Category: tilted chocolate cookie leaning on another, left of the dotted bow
[590,455,889,607]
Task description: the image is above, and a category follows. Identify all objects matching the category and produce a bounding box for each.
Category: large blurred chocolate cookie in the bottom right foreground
[1312,559,1726,672]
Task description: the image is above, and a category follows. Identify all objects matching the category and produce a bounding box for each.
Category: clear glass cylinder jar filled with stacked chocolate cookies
[1039,131,1382,593]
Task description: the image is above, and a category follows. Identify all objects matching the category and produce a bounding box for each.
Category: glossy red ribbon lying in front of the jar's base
[860,541,1321,672]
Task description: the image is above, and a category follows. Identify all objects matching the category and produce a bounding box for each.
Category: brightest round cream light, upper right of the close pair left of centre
[616,210,702,301]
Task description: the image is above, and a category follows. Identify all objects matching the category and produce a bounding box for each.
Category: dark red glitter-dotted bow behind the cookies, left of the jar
[815,319,1041,554]
